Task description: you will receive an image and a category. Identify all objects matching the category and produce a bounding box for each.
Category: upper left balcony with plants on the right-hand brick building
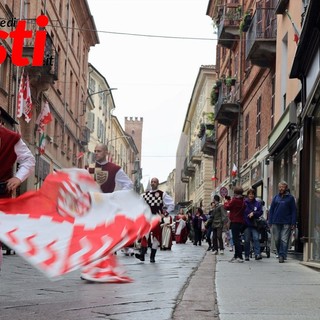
[218,1,241,49]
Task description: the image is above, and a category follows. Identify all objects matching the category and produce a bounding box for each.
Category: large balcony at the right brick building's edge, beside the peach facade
[246,8,277,68]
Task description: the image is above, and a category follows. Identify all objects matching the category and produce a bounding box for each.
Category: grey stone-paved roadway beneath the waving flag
[0,242,214,320]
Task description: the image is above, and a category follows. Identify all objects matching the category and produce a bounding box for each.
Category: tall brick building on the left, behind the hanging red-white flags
[0,0,99,191]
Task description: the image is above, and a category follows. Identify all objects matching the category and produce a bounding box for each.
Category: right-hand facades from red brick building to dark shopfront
[207,0,319,258]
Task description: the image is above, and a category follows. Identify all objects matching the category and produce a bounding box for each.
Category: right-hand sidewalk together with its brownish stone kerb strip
[172,250,320,320]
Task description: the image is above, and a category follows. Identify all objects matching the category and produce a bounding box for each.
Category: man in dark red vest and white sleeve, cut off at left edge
[0,124,35,269]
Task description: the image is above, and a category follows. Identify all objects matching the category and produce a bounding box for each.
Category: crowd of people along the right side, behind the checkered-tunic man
[151,181,296,263]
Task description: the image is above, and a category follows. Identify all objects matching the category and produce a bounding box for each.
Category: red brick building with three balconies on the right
[207,0,277,208]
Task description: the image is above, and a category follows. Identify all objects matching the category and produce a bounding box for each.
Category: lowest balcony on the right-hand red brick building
[214,85,240,126]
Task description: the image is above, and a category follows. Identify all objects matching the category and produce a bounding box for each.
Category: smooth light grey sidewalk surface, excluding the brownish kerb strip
[215,251,320,320]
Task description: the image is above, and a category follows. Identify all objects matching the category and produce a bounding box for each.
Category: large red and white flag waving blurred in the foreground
[0,169,159,282]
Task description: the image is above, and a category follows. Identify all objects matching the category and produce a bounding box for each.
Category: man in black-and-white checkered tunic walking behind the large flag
[135,178,174,263]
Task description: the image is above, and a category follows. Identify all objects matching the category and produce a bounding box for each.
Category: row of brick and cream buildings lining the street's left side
[0,0,141,193]
